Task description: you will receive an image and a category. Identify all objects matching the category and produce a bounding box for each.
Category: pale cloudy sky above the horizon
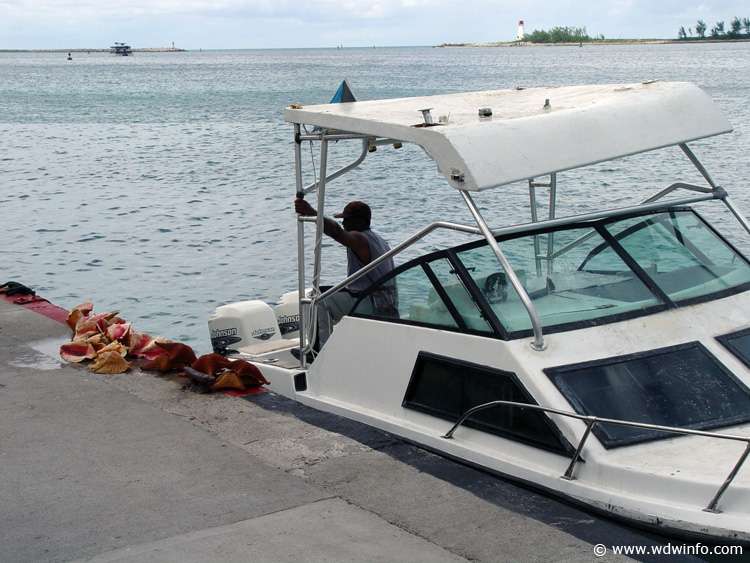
[0,0,750,49]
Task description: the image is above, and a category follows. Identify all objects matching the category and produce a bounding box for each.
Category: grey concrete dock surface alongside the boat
[0,300,697,563]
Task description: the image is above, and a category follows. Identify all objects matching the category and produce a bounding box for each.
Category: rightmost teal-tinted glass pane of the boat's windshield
[606,210,750,302]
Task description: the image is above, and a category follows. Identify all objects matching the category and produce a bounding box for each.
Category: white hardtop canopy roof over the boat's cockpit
[284,82,732,191]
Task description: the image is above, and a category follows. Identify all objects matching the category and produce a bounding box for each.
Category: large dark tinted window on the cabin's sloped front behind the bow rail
[544,342,750,448]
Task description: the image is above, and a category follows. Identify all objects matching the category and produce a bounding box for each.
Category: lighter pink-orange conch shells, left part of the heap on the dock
[60,301,170,373]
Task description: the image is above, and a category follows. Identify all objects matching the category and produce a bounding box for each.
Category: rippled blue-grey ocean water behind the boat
[0,43,750,353]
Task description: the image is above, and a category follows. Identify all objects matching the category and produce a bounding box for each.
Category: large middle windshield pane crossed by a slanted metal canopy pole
[457,228,661,334]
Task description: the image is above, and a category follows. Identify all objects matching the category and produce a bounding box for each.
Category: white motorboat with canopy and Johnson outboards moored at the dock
[209,82,750,544]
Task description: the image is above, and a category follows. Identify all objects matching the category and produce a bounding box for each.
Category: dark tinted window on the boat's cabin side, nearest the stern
[403,352,572,453]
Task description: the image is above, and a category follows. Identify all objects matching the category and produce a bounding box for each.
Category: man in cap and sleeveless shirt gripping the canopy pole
[294,198,397,350]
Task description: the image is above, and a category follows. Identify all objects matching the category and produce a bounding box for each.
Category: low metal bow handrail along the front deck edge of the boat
[442,401,750,513]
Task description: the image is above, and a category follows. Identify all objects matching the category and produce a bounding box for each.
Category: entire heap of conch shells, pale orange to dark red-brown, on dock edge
[60,301,268,393]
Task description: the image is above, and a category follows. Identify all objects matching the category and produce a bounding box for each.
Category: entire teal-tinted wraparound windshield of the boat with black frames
[353,208,750,338]
